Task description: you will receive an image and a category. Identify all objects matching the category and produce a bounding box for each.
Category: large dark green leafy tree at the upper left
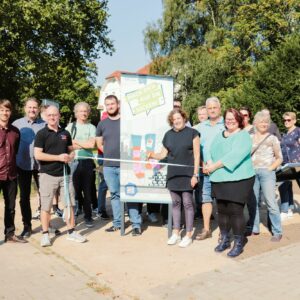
[0,0,113,121]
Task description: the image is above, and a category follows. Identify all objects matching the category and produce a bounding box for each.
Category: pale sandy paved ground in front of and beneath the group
[0,189,300,300]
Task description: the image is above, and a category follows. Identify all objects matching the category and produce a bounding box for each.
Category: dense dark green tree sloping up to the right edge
[219,33,300,128]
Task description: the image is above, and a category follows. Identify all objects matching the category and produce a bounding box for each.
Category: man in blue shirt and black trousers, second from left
[13,97,45,238]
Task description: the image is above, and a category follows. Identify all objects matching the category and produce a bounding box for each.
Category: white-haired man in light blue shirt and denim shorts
[194,97,225,240]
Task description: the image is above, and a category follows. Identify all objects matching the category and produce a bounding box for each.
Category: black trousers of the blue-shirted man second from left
[18,168,40,228]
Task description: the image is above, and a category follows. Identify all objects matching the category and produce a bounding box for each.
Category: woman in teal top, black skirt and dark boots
[204,108,255,257]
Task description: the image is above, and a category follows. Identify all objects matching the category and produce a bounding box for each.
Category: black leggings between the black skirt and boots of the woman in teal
[217,199,246,235]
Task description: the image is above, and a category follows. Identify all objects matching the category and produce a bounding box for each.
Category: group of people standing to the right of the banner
[154,97,300,257]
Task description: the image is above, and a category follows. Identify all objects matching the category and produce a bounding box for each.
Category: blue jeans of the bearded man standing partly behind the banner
[103,167,142,228]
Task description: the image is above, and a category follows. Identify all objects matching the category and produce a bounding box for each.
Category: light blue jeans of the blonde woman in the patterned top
[248,169,282,236]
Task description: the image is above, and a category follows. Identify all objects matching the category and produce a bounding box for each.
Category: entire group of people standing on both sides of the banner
[0,95,300,257]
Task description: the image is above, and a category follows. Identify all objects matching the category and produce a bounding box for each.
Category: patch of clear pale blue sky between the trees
[96,0,163,86]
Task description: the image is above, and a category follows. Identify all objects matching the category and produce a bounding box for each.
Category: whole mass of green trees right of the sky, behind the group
[145,0,300,120]
